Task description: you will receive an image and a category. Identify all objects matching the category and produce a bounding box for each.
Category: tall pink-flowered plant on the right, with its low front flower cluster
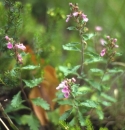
[56,3,121,127]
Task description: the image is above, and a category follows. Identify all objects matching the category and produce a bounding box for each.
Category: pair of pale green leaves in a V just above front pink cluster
[59,65,80,76]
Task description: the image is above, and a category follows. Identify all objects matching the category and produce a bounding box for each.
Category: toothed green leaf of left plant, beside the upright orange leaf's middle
[23,78,42,88]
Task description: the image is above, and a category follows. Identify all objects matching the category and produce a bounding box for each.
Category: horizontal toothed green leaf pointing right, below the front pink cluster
[80,100,99,108]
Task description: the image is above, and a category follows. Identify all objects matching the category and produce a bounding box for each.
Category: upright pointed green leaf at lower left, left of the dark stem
[11,91,24,107]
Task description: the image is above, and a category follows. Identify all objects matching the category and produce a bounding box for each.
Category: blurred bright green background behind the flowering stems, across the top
[0,0,125,66]
